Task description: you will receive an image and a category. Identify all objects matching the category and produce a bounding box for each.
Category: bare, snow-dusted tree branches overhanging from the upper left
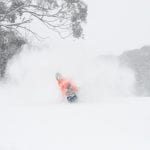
[0,0,87,38]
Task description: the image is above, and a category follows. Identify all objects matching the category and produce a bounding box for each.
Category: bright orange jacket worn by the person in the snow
[58,79,78,96]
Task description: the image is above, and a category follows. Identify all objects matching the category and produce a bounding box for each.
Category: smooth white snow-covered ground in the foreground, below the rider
[0,99,150,150]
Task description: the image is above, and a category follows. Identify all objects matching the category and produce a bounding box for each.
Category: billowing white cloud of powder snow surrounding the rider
[0,46,135,105]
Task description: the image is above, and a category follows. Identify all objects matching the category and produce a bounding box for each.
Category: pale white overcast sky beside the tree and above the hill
[30,0,150,54]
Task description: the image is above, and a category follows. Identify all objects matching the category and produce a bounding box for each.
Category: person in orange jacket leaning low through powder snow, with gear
[55,73,78,102]
